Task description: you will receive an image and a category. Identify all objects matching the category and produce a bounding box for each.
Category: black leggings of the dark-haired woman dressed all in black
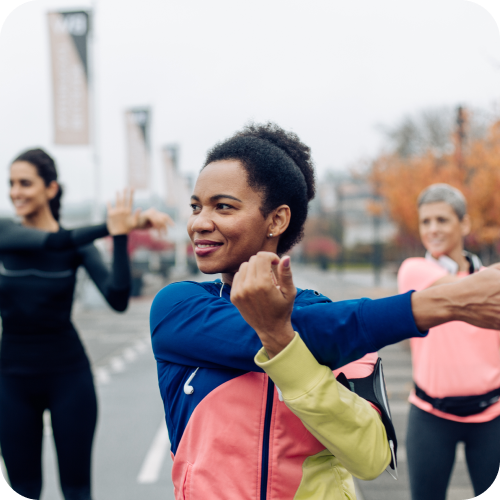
[0,368,97,500]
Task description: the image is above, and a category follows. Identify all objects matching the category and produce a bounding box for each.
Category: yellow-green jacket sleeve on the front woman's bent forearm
[255,333,391,480]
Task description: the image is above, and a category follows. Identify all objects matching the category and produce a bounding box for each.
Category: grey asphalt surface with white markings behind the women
[0,266,480,500]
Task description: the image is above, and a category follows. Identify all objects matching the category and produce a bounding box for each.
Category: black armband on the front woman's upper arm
[337,358,398,479]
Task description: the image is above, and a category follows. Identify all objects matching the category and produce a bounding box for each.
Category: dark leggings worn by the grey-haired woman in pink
[406,405,500,500]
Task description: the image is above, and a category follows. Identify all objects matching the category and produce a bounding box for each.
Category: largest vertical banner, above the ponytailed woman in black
[48,11,90,145]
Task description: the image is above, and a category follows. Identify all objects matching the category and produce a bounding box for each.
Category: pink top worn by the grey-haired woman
[398,258,500,423]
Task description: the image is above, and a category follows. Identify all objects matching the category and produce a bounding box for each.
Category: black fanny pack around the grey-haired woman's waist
[415,384,500,417]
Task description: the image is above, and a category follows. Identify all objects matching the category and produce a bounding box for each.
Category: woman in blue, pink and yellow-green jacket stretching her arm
[150,124,500,500]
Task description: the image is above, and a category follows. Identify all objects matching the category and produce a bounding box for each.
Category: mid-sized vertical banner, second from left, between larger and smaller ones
[125,108,151,189]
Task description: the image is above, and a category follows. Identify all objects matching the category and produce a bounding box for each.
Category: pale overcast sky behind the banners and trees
[0,0,500,210]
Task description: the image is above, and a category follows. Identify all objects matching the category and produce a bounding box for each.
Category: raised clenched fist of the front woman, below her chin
[231,252,297,358]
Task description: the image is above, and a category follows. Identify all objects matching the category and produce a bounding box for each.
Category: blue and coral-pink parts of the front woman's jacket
[150,280,425,500]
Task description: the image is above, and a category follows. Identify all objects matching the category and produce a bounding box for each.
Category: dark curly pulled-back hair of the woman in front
[203,123,315,255]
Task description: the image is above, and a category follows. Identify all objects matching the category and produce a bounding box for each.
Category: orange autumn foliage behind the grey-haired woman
[370,121,500,244]
